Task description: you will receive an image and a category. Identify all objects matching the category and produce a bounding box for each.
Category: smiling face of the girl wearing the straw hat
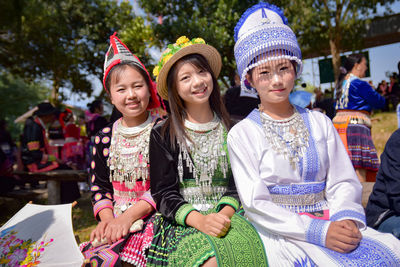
[176,61,213,107]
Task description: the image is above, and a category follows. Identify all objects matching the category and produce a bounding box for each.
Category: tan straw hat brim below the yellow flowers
[157,44,222,100]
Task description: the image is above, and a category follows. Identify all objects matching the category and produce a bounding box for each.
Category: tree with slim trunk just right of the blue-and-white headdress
[273,0,394,80]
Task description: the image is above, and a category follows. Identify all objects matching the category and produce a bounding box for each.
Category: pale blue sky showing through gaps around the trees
[65,0,400,109]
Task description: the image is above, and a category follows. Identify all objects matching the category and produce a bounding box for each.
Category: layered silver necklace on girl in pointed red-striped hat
[107,115,153,189]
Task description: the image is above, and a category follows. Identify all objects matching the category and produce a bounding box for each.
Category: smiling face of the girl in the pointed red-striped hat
[110,65,150,124]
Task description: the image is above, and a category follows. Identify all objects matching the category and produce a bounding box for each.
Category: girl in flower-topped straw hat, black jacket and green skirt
[148,36,267,266]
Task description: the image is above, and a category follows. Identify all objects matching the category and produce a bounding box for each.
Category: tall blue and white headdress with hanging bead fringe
[234,3,303,94]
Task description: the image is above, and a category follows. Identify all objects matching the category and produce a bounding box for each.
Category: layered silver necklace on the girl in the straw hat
[178,114,228,195]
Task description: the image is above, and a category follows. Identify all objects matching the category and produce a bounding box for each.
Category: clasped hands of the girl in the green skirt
[195,213,231,237]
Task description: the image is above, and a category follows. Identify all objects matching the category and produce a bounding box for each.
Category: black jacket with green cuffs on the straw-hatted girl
[150,121,239,226]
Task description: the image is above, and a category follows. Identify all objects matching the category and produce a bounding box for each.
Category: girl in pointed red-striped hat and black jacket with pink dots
[83,34,160,266]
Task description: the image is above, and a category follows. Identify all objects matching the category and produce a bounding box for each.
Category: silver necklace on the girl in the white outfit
[260,108,310,169]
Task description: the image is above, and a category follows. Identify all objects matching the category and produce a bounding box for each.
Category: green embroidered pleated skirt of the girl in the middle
[147,213,268,267]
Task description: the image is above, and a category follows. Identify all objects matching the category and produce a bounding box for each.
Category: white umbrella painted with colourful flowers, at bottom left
[0,204,84,267]
